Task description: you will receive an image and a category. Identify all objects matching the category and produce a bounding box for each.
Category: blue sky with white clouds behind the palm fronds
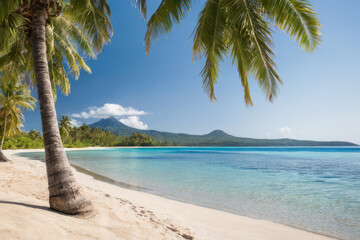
[25,0,360,143]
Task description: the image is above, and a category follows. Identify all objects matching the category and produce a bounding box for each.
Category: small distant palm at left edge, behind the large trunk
[0,83,36,162]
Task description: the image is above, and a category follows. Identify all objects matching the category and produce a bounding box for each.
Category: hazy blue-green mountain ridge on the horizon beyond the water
[89,117,357,147]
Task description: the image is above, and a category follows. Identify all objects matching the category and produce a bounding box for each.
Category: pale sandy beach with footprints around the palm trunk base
[0,150,331,240]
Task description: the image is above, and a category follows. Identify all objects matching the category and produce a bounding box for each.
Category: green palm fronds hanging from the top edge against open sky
[137,0,321,105]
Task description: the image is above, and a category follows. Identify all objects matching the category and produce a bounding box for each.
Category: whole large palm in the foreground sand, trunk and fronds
[0,0,112,214]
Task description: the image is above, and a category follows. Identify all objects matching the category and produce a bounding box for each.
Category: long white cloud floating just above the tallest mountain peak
[71,103,146,119]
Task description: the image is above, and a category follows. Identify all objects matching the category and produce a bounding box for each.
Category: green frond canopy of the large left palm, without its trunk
[0,0,112,97]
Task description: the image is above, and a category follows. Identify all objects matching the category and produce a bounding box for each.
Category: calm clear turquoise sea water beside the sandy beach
[22,147,360,240]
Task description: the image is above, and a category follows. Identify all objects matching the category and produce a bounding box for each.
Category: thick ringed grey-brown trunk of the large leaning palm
[32,0,93,214]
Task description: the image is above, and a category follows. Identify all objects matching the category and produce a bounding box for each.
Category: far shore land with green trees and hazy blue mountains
[3,117,358,149]
